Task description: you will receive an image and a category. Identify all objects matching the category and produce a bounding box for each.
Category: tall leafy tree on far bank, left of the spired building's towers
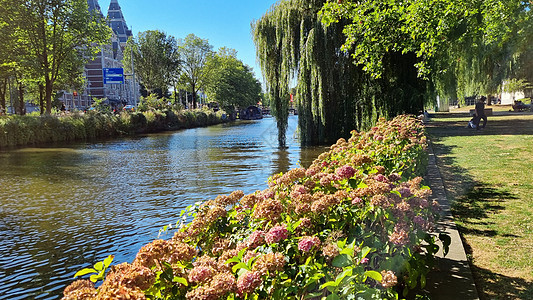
[15,0,110,114]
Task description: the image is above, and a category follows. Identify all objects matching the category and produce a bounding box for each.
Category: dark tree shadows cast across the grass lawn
[427,116,533,300]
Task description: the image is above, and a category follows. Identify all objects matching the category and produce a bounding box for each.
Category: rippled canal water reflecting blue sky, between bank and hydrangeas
[0,116,325,299]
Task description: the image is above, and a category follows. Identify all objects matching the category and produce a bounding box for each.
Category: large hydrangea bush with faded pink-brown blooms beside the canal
[63,116,447,300]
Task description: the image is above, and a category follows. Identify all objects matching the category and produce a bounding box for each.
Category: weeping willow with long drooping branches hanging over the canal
[252,0,427,147]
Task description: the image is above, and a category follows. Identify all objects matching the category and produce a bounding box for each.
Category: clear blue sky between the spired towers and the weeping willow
[98,0,277,80]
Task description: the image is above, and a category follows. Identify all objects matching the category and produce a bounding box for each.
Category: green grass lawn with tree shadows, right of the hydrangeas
[428,113,533,299]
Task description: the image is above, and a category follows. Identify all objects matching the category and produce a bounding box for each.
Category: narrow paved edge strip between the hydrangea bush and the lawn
[426,145,479,300]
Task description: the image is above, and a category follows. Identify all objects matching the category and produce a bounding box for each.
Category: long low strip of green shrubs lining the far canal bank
[0,109,226,148]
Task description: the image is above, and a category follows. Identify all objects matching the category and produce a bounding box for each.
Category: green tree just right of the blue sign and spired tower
[124,30,180,94]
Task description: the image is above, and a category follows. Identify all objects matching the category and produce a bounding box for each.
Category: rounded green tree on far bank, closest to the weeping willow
[206,48,261,112]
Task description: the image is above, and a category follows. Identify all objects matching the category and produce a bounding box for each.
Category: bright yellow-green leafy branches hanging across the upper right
[321,0,531,102]
